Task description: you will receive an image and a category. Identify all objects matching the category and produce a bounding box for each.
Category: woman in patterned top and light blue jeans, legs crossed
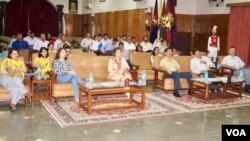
[53,48,83,104]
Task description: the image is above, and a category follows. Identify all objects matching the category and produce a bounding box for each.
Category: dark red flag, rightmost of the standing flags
[165,0,177,44]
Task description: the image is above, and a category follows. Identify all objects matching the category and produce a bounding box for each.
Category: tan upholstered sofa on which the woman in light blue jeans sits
[52,54,111,101]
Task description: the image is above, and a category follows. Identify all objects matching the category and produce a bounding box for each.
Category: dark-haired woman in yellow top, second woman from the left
[32,47,51,76]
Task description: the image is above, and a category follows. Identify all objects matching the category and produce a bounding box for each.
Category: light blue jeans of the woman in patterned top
[57,74,83,98]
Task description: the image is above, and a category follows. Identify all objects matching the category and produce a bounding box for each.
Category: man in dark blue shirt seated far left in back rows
[11,33,29,50]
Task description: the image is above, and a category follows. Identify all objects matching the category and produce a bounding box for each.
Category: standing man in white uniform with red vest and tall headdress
[207,25,220,62]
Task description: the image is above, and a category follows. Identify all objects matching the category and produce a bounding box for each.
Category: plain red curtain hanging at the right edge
[227,6,250,64]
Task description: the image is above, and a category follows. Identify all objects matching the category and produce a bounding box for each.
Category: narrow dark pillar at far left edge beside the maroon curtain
[0,1,7,36]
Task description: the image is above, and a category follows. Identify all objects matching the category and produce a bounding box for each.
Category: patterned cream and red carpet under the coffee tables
[42,92,250,127]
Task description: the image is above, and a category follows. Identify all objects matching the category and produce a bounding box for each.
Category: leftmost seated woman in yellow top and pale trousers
[0,49,32,110]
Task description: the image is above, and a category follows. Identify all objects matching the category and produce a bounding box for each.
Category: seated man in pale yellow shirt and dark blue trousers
[160,48,192,97]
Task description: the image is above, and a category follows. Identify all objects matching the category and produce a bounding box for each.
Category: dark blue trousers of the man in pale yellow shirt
[164,72,192,90]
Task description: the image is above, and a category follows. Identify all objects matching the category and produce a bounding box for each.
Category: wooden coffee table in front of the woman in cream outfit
[79,82,145,114]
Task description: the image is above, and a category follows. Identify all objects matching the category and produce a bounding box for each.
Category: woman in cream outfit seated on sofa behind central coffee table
[108,48,131,81]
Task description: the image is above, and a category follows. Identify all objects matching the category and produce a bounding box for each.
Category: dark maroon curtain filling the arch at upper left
[6,0,58,36]
